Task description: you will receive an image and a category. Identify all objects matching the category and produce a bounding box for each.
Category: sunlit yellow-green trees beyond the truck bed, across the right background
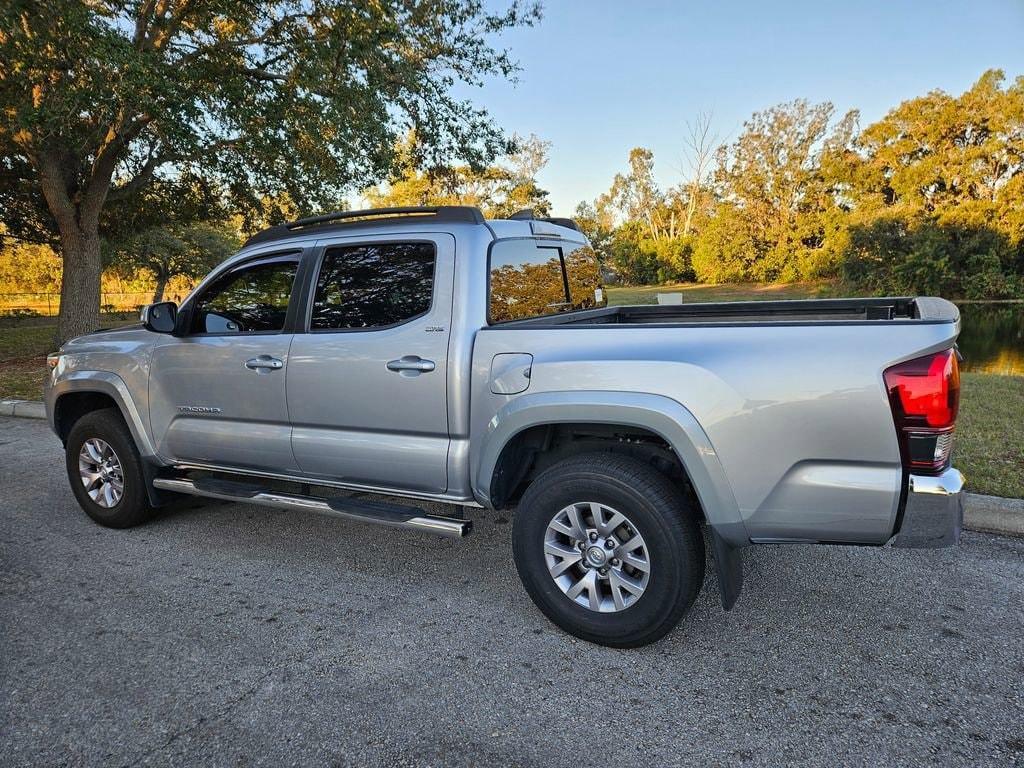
[581,71,1024,298]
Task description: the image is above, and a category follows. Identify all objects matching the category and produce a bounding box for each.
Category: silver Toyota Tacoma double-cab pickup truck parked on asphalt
[46,207,964,647]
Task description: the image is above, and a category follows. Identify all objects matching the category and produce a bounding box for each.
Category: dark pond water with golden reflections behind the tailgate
[956,302,1024,376]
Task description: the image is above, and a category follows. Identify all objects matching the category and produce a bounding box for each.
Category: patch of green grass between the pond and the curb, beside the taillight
[953,374,1024,499]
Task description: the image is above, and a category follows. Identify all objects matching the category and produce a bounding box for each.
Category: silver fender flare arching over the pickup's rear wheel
[471,390,750,547]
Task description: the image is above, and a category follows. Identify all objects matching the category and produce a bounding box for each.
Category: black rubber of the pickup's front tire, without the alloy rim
[65,408,154,528]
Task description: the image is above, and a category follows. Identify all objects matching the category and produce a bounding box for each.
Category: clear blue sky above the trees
[459,0,1024,215]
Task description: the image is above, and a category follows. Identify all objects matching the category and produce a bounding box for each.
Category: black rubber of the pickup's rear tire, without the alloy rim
[512,453,705,648]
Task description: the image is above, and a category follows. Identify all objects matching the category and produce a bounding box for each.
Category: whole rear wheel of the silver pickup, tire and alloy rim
[512,454,705,647]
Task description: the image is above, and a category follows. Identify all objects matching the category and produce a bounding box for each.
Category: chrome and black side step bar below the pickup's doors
[153,477,473,539]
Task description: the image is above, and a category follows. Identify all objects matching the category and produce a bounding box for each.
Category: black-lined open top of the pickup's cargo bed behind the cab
[495,297,959,328]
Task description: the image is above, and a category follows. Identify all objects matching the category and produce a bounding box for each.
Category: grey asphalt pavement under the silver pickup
[0,419,1024,767]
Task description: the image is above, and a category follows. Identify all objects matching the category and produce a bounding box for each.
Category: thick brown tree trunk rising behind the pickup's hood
[57,227,102,343]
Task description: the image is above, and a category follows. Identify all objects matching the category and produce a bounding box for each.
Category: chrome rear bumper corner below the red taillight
[892,467,964,549]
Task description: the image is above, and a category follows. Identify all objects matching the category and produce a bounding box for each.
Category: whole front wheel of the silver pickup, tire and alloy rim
[65,409,154,528]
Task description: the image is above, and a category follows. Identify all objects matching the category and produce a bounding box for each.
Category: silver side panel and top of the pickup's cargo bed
[469,290,959,544]
